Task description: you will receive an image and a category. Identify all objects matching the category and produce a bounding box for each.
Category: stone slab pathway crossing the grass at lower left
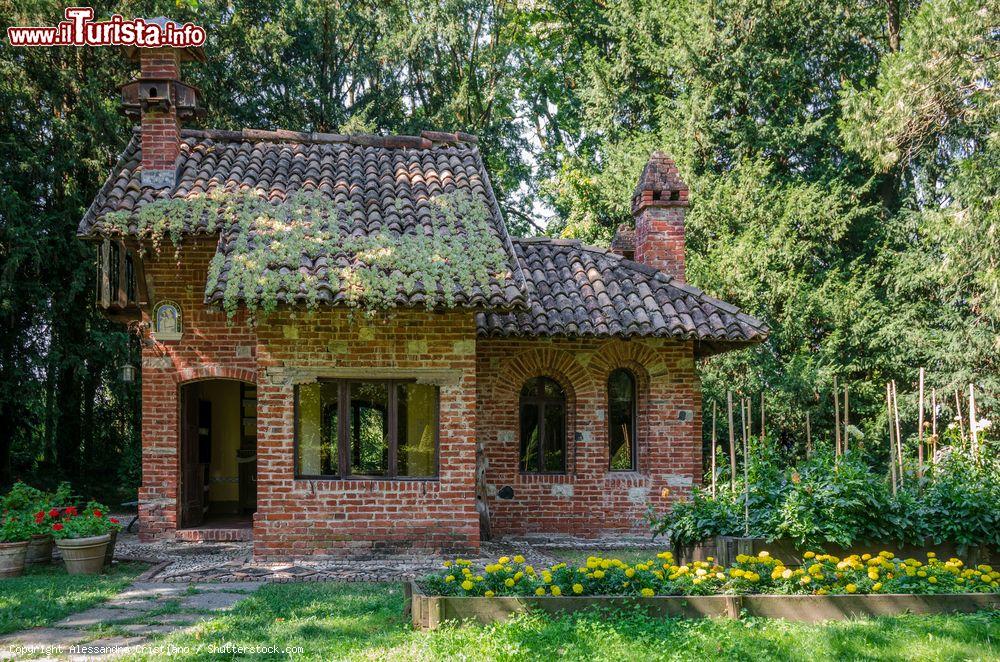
[0,582,263,660]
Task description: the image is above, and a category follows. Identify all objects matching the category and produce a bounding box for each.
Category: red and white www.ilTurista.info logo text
[7,7,205,48]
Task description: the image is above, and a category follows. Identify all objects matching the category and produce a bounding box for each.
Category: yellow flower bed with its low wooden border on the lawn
[410,551,1000,627]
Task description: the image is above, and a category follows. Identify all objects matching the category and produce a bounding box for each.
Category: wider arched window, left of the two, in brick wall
[519,377,566,473]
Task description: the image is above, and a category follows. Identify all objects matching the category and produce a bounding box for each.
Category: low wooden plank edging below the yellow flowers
[404,582,1000,630]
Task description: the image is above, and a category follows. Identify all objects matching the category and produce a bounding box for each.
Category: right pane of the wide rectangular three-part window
[396,384,438,476]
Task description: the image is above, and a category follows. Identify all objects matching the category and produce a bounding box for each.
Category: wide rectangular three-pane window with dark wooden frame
[295,380,439,478]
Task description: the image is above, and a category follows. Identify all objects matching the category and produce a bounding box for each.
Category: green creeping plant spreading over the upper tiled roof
[103,191,510,317]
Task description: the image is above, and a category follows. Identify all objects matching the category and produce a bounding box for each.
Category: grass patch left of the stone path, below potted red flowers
[0,563,146,634]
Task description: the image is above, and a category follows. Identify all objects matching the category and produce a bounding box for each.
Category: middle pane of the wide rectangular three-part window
[349,382,389,476]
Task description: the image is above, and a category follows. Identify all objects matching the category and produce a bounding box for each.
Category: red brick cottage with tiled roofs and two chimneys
[79,41,767,559]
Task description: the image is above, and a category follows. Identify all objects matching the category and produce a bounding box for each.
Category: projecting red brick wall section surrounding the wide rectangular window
[254,309,479,558]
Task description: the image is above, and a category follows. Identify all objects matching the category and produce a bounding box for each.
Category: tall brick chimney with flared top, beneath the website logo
[122,17,205,188]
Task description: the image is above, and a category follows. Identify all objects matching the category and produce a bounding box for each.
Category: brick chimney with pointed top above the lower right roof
[632,151,688,282]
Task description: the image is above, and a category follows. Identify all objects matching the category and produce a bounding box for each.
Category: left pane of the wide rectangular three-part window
[295,383,337,476]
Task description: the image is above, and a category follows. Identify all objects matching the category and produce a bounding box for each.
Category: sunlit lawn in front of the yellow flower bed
[125,583,1000,662]
